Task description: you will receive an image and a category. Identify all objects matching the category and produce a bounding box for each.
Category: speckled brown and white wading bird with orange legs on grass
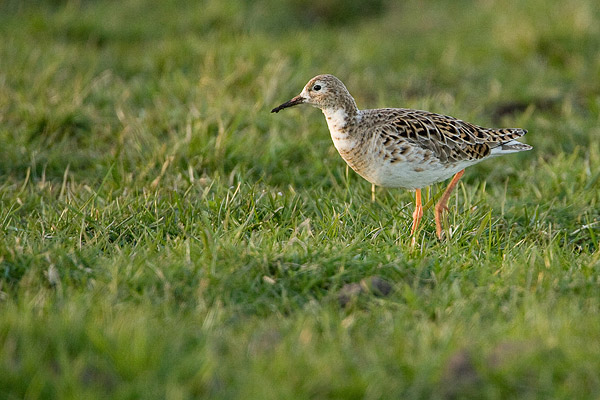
[271,74,532,239]
